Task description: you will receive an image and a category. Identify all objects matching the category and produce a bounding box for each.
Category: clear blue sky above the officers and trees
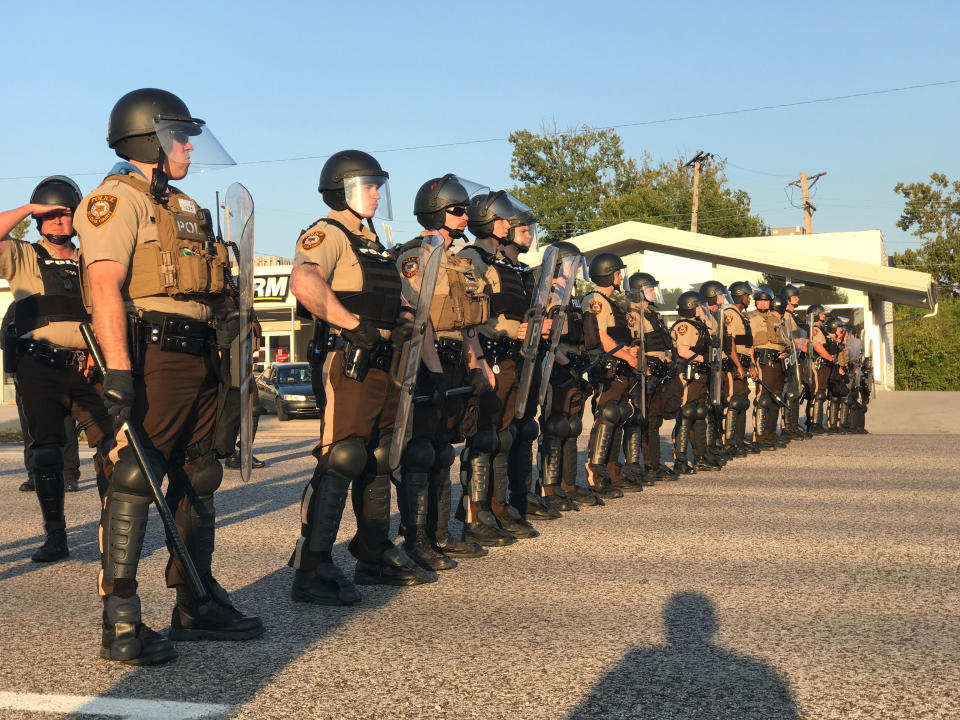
[0,1,960,256]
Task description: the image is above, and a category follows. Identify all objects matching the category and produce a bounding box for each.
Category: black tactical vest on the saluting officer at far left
[13,243,90,335]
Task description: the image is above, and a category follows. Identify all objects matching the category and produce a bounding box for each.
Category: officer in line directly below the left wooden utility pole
[670,290,720,475]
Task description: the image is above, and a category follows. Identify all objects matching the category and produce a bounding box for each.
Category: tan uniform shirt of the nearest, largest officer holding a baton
[73,173,220,320]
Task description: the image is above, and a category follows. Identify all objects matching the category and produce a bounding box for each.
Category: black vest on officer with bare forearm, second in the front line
[311,218,402,330]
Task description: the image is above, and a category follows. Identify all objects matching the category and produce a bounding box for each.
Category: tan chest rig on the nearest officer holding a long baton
[83,175,232,308]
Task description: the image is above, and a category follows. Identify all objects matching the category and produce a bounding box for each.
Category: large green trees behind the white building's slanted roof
[510,127,767,242]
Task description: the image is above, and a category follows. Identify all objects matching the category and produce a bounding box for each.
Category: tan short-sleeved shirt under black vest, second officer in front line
[293,210,390,338]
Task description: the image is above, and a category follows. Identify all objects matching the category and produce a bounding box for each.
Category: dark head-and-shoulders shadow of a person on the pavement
[568,592,801,720]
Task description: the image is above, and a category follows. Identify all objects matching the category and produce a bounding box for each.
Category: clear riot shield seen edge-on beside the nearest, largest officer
[223,183,255,482]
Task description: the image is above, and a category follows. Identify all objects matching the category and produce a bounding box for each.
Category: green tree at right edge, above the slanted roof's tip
[893,173,960,292]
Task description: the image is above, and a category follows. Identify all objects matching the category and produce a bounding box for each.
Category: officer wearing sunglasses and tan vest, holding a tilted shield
[397,173,495,570]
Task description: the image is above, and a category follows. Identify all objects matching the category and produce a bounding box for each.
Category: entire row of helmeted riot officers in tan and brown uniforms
[0,88,865,665]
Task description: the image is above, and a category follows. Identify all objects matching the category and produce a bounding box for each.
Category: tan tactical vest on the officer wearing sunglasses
[398,237,490,332]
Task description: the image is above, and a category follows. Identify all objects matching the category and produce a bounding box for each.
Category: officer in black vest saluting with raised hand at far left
[0,175,113,562]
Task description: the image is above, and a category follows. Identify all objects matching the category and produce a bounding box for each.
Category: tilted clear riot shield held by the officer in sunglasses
[389,233,444,468]
